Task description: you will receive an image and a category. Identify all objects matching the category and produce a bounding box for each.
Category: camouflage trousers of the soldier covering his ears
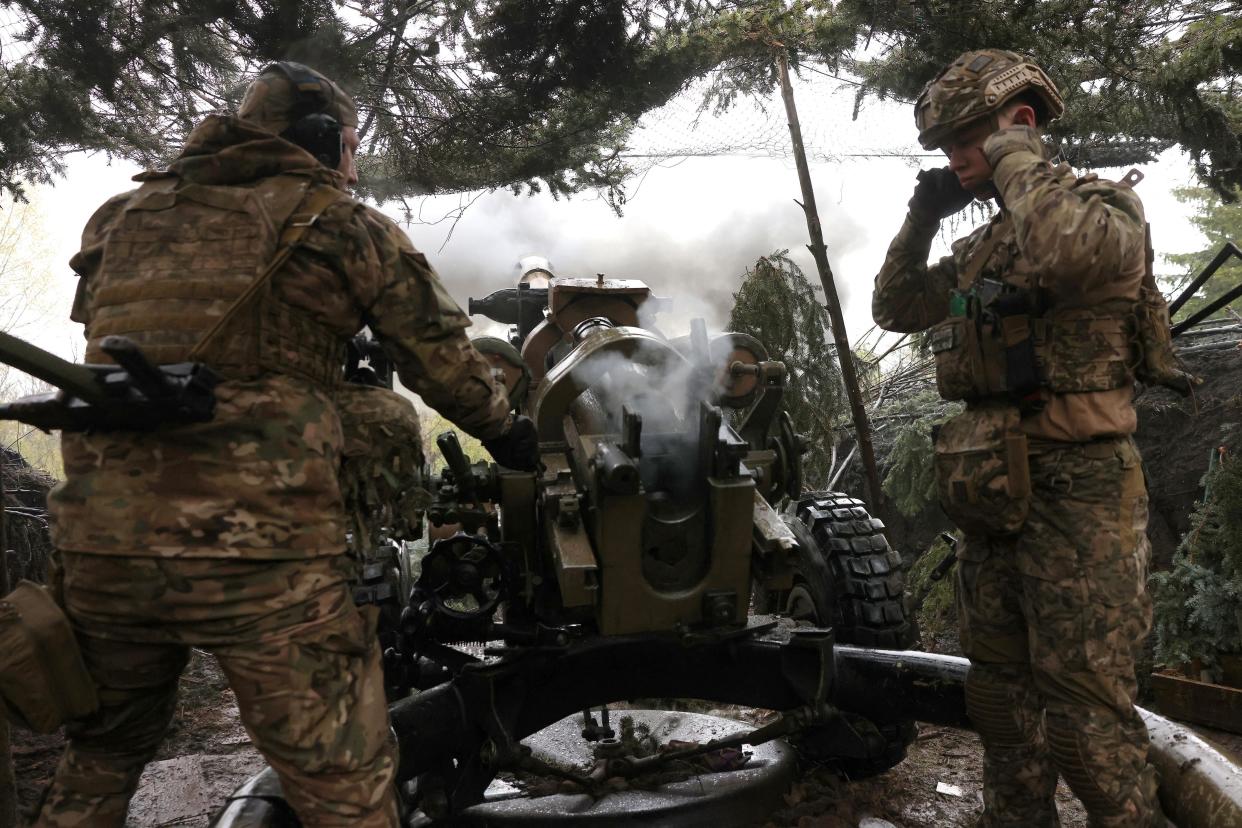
[958,438,1165,828]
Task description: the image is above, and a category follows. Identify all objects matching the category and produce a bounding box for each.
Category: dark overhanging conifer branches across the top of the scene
[0,0,1242,202]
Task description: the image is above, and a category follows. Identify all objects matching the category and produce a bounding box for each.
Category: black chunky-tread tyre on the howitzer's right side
[755,492,917,778]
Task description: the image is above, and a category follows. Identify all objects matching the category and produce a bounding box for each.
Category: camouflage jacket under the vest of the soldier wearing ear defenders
[48,115,509,559]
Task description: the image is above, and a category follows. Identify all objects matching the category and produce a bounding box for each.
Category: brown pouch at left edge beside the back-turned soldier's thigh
[0,581,99,734]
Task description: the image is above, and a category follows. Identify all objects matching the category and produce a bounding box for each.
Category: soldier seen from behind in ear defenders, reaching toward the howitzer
[37,63,535,828]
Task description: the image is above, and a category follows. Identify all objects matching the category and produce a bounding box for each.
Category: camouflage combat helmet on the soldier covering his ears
[914,48,1066,149]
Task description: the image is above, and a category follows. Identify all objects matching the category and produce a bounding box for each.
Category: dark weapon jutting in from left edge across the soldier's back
[0,333,220,431]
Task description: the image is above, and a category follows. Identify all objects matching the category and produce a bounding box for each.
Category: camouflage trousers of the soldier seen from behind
[35,552,397,828]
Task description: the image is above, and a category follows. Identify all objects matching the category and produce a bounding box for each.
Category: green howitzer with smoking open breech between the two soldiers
[211,277,914,826]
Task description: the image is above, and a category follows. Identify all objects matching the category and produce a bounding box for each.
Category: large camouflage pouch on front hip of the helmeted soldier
[935,405,1031,535]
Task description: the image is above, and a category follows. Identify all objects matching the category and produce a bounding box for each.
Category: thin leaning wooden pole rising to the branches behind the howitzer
[777,50,884,510]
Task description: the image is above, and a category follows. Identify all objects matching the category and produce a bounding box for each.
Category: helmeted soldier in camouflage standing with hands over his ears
[872,50,1165,828]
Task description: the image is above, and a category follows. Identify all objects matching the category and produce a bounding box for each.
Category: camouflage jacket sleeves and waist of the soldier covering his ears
[872,130,1146,442]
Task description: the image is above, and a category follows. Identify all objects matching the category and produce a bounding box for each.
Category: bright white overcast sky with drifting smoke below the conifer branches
[0,69,1202,367]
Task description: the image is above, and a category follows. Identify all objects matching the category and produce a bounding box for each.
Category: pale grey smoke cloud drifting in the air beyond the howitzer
[392,158,874,336]
